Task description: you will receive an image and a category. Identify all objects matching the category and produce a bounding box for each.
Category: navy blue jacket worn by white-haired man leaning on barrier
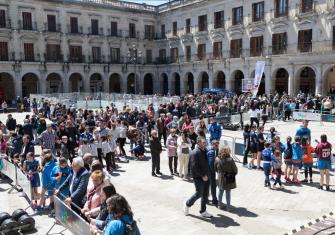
[59,168,90,208]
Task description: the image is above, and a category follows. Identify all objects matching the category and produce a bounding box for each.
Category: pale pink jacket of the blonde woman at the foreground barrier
[84,184,103,218]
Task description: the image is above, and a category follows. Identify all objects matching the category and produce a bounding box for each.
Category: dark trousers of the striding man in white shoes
[186,178,209,213]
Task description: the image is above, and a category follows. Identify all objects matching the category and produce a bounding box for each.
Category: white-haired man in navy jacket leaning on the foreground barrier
[55,157,90,214]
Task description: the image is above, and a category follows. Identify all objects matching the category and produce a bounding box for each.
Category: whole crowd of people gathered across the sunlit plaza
[0,90,333,229]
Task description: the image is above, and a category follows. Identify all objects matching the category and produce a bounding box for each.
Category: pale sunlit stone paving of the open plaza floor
[0,114,335,235]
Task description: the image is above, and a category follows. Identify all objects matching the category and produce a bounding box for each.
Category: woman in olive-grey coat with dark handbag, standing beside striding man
[214,146,237,211]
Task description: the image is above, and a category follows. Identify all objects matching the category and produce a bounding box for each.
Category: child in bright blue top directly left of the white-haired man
[51,157,72,200]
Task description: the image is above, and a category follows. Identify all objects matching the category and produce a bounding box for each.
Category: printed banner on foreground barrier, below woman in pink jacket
[55,197,91,235]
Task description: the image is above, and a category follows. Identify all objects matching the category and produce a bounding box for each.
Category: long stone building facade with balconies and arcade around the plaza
[0,0,335,100]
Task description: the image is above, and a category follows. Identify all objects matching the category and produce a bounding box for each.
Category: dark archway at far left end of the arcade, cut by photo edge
[0,73,15,105]
